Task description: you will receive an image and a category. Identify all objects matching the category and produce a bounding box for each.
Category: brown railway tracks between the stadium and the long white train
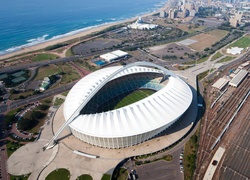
[197,78,250,179]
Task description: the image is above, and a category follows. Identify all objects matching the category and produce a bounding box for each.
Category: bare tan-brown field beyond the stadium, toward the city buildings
[189,29,228,51]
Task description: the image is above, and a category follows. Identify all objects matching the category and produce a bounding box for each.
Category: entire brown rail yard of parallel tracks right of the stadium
[194,64,250,179]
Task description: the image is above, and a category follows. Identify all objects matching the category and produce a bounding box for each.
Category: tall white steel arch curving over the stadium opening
[45,62,176,149]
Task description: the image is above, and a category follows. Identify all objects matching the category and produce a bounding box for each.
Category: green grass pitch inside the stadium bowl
[114,89,154,109]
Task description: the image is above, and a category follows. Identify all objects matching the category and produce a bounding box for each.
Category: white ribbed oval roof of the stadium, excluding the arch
[64,66,192,137]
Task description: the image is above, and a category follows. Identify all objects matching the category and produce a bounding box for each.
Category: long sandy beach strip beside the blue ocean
[0,0,171,60]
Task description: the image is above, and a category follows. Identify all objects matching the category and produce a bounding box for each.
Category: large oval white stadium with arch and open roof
[48,62,192,149]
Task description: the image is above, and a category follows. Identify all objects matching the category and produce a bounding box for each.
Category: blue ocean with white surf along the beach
[0,0,166,55]
